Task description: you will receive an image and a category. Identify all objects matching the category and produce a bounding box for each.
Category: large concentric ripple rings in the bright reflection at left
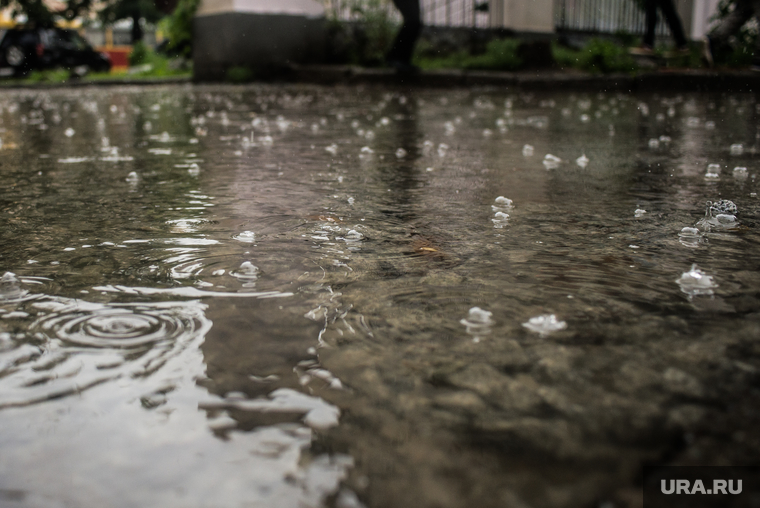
[0,297,212,408]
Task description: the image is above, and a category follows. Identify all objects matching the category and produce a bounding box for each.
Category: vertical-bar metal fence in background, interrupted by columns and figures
[325,0,669,36]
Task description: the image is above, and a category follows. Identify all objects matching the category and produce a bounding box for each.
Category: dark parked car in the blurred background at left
[0,27,111,76]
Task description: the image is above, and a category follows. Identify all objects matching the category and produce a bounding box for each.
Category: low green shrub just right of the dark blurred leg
[414,39,523,71]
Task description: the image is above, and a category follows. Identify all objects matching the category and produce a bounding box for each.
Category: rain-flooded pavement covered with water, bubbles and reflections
[0,85,760,508]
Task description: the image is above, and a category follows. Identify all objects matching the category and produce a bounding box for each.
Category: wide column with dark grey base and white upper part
[193,0,326,80]
